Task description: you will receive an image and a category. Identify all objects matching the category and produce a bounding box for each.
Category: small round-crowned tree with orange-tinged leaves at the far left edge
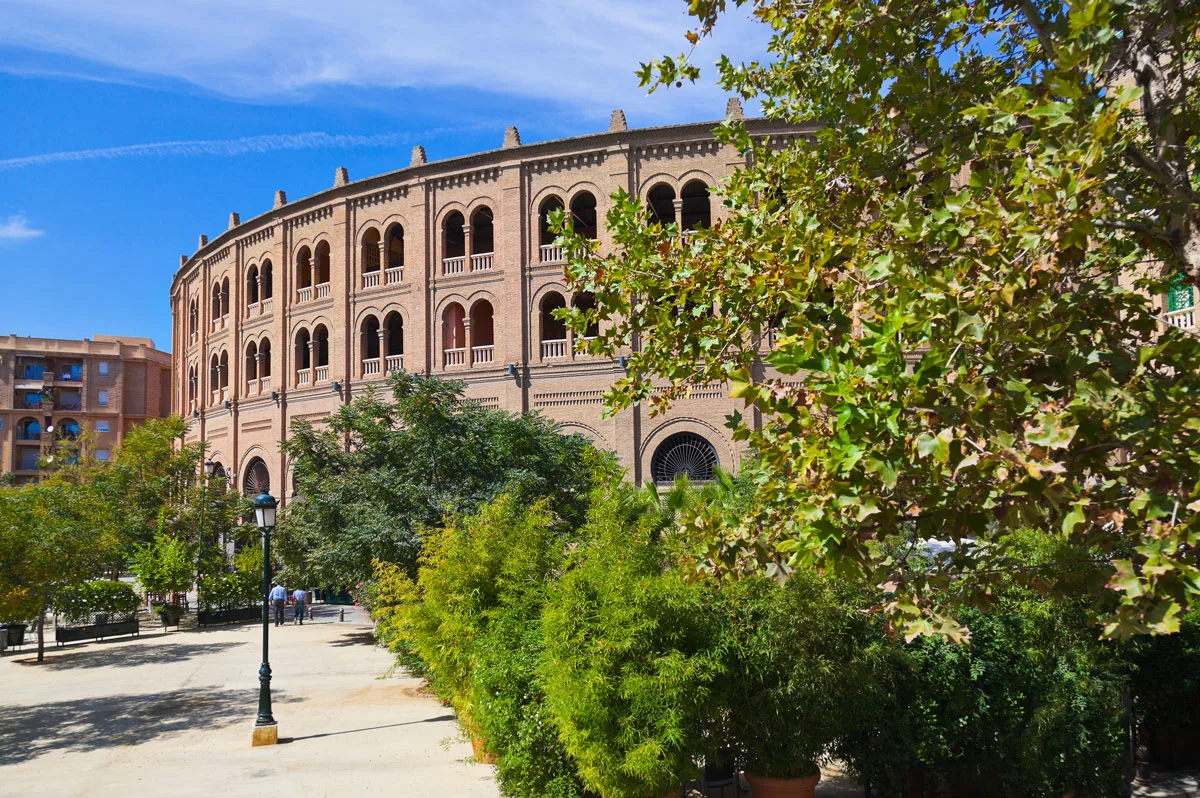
[0,474,120,662]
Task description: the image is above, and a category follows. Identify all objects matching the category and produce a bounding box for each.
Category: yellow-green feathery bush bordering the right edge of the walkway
[367,493,582,798]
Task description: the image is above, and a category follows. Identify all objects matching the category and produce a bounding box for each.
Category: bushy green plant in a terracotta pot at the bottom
[720,571,872,798]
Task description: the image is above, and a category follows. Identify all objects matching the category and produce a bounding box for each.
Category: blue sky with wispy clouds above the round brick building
[0,0,763,349]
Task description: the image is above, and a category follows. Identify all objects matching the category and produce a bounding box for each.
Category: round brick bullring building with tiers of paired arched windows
[170,101,802,497]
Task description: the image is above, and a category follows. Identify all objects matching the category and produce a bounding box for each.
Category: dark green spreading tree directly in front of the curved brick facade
[277,373,595,586]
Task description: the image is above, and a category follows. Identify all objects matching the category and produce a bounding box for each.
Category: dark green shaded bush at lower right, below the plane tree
[839,592,1128,798]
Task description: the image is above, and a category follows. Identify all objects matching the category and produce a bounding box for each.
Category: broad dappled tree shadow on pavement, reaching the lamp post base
[0,688,299,767]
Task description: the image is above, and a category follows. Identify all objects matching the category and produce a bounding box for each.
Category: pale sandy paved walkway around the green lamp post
[0,606,499,798]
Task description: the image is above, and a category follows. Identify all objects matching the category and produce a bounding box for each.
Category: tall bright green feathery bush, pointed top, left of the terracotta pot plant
[541,486,736,798]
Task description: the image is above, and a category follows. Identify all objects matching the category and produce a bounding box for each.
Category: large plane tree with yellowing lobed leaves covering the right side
[560,0,1200,637]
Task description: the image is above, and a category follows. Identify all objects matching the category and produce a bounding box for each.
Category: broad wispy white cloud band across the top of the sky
[0,0,766,119]
